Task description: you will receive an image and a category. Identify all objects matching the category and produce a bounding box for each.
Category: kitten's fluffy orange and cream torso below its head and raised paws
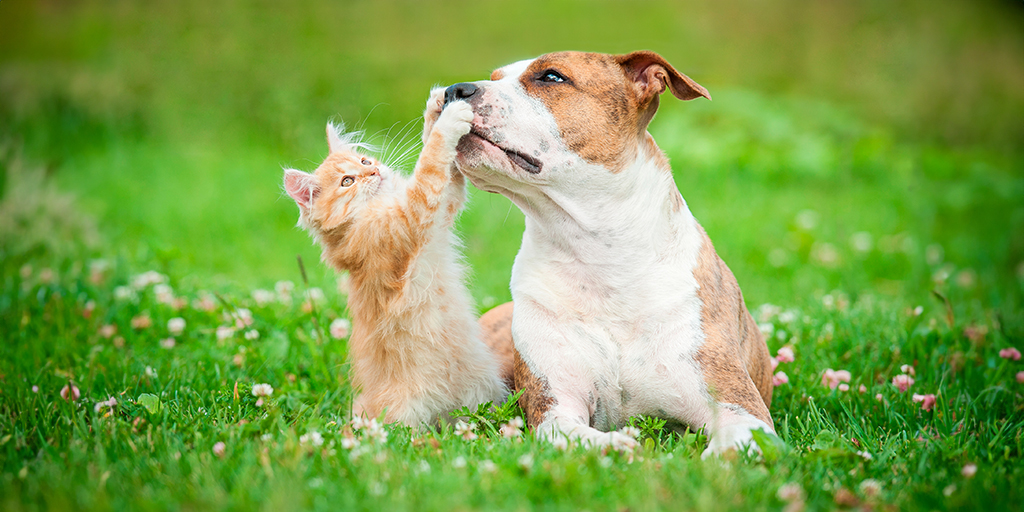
[349,201,505,424]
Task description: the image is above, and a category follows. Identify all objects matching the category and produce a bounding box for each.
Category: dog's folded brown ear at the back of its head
[615,50,711,104]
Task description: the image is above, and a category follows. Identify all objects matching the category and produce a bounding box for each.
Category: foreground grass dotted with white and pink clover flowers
[0,258,1024,510]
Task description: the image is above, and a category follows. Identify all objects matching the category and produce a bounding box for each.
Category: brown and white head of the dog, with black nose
[445,51,711,201]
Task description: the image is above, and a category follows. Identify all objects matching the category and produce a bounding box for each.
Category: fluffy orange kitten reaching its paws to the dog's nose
[285,94,508,427]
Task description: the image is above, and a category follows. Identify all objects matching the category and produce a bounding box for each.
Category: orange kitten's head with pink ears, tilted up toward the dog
[285,123,400,239]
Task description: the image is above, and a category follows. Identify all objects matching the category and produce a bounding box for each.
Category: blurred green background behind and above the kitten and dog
[0,0,1024,307]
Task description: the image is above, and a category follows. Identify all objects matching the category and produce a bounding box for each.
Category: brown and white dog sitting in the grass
[445,51,774,457]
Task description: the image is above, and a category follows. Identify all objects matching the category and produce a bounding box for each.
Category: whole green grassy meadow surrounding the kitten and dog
[0,0,1024,511]
